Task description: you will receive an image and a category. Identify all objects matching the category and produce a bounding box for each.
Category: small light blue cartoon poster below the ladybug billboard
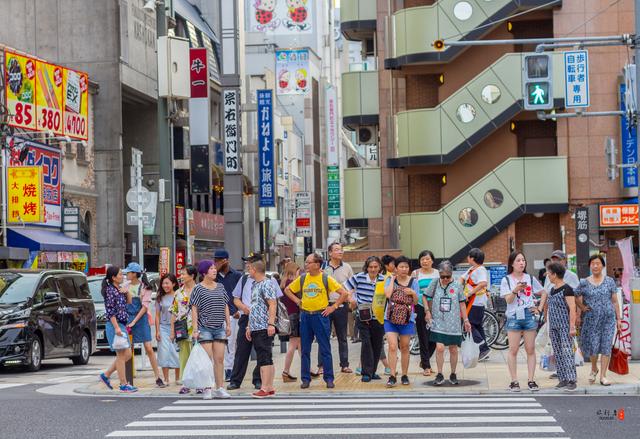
[276,49,310,95]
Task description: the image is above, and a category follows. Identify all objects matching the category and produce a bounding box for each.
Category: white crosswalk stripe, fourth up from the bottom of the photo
[160,399,541,413]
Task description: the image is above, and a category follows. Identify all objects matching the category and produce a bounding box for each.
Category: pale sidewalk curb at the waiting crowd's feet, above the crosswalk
[73,383,640,399]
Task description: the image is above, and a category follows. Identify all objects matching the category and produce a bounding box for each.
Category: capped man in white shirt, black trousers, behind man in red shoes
[227,253,282,390]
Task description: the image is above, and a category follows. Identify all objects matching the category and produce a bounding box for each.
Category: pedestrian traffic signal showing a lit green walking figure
[522,54,553,110]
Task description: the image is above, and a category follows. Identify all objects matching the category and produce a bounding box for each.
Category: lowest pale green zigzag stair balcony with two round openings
[399,157,569,262]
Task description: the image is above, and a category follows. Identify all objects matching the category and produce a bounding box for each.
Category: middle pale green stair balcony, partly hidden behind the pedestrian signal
[388,53,565,168]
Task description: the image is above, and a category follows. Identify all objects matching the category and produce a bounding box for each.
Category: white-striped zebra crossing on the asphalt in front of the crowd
[107,395,568,439]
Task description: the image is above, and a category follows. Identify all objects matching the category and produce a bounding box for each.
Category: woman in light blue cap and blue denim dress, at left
[122,262,165,387]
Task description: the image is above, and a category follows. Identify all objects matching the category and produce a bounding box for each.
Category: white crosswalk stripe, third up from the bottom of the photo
[145,407,549,419]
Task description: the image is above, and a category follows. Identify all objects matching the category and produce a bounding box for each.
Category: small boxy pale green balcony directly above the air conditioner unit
[342,70,379,130]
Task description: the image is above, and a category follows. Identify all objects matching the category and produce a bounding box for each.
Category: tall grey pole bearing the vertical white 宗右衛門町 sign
[219,0,244,267]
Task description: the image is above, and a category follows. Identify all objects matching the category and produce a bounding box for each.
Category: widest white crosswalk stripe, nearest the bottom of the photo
[107,428,569,439]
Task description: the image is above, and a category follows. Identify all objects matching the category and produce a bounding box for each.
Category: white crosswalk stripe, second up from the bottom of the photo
[126,416,556,427]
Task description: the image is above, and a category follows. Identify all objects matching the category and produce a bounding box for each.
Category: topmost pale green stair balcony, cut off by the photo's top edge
[384,0,562,69]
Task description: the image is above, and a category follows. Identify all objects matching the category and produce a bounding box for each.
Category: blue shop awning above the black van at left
[7,229,91,253]
